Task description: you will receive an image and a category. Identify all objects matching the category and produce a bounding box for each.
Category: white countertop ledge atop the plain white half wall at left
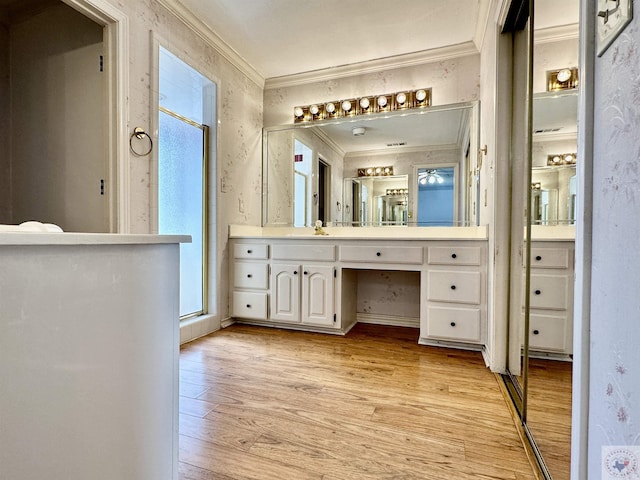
[0,232,191,245]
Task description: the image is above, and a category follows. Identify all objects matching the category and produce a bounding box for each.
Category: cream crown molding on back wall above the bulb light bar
[264,41,479,90]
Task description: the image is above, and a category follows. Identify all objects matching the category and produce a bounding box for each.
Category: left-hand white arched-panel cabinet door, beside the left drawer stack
[270,263,301,322]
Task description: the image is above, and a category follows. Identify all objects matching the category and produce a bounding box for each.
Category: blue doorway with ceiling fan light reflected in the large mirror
[417,167,455,226]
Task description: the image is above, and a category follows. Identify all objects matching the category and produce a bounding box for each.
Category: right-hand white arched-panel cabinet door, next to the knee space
[302,265,334,327]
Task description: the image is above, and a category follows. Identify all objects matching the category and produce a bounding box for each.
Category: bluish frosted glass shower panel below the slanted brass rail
[158,112,204,317]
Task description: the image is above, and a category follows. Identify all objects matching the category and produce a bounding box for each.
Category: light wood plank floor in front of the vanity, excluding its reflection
[180,324,536,480]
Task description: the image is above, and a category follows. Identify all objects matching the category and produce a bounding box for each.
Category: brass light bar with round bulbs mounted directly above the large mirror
[293,88,431,123]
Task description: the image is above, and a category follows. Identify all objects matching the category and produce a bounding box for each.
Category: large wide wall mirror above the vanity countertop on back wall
[263,102,479,227]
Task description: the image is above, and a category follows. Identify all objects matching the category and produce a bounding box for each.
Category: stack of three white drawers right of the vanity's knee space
[420,242,486,345]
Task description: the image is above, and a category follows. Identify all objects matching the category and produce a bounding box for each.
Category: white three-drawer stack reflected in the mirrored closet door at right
[529,241,574,356]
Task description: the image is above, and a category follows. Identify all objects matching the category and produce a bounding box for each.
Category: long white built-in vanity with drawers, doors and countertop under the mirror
[229,226,487,349]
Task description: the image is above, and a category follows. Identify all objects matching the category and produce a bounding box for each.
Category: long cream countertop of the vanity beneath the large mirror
[229,225,487,241]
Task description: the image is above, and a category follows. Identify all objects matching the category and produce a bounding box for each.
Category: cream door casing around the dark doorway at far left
[63,0,131,233]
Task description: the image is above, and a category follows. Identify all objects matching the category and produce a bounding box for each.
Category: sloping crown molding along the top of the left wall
[158,0,265,88]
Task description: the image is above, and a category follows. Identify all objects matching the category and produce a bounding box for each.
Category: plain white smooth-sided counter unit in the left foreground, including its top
[0,232,190,480]
